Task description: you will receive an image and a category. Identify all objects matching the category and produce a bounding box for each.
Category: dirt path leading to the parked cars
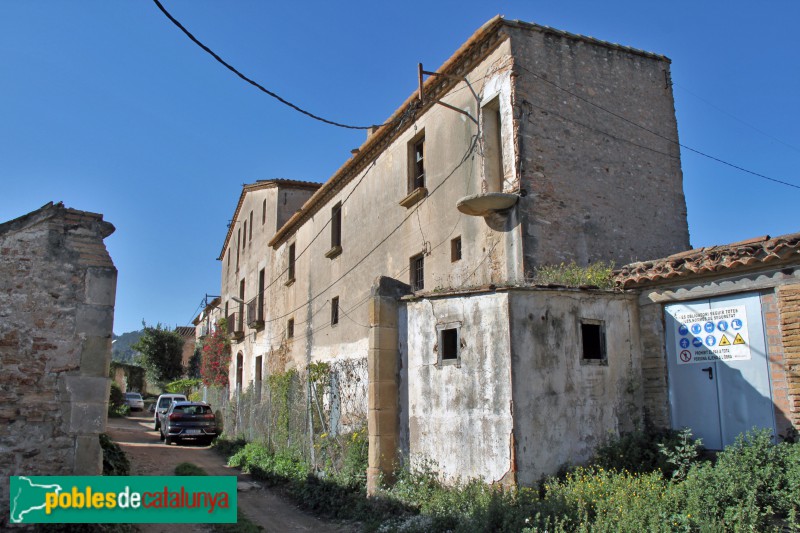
[107,412,355,533]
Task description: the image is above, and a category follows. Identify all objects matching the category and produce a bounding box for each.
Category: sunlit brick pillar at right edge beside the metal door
[776,284,800,433]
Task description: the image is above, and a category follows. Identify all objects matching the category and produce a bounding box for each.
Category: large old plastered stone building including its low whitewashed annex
[219,17,689,484]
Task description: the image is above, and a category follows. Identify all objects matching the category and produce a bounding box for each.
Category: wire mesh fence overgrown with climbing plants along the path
[203,358,367,472]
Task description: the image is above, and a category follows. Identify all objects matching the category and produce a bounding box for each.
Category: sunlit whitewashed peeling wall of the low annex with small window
[400,293,513,483]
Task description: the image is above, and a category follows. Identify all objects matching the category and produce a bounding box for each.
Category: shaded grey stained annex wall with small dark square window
[509,289,642,485]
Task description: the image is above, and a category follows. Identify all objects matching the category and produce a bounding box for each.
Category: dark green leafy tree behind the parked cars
[132,322,183,382]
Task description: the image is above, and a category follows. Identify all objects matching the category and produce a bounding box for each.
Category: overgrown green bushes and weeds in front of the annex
[216,431,800,533]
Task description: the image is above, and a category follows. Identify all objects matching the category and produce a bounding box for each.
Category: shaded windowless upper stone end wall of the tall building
[508,26,689,271]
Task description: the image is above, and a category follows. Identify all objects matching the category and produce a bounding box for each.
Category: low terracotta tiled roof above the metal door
[614,233,800,289]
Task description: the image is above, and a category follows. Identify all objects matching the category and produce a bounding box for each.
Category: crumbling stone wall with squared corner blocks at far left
[0,203,117,520]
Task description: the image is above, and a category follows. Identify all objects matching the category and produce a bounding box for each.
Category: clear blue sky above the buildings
[0,0,800,334]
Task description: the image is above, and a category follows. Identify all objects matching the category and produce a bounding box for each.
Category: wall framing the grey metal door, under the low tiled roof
[638,265,800,435]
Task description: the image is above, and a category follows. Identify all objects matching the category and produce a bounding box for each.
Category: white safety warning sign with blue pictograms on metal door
[675,305,750,365]
